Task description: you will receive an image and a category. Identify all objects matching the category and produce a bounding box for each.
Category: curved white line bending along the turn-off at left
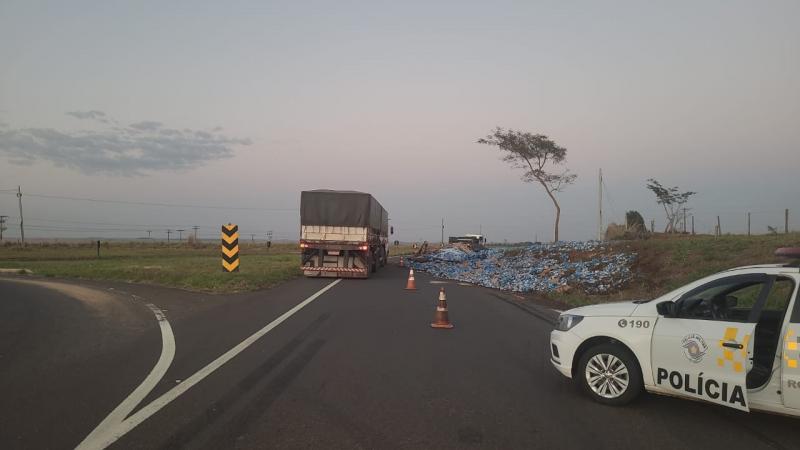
[77,303,175,449]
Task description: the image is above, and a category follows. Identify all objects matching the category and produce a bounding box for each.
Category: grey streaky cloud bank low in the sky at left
[0,111,251,175]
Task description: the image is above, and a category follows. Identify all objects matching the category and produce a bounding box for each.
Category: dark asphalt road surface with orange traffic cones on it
[0,267,800,449]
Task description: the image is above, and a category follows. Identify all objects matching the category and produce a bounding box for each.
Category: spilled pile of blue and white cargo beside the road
[409,241,636,294]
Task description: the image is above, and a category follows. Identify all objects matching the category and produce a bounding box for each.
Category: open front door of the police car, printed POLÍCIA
[651,274,771,411]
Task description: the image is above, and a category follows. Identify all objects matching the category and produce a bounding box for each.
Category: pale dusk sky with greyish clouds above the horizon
[0,0,800,242]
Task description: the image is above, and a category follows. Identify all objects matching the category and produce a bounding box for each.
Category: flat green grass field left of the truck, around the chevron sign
[0,242,301,293]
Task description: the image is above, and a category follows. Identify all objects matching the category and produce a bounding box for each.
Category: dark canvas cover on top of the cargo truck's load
[300,189,389,236]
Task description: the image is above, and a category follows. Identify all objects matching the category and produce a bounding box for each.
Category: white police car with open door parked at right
[550,248,800,416]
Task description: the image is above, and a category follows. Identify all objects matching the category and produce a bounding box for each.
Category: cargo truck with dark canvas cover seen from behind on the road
[300,189,389,278]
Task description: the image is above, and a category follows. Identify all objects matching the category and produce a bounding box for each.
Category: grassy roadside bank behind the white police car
[548,233,800,305]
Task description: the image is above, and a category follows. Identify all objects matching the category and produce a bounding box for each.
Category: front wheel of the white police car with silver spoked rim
[575,344,643,405]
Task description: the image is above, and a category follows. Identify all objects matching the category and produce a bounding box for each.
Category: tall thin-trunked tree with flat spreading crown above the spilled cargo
[478,127,577,242]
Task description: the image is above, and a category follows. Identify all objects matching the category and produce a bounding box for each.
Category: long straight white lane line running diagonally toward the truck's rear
[81,278,342,449]
